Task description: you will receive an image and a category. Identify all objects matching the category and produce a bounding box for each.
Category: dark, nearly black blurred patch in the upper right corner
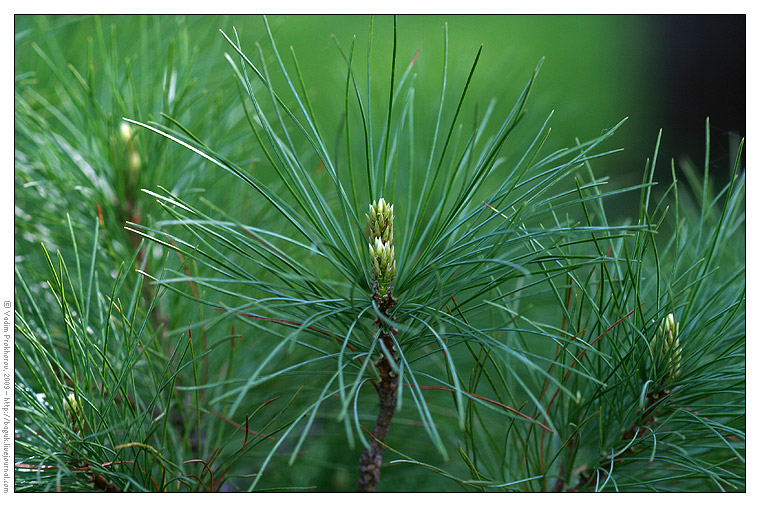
[655,15,747,185]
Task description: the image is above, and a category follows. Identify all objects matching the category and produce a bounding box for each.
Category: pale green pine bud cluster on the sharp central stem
[367,198,396,296]
